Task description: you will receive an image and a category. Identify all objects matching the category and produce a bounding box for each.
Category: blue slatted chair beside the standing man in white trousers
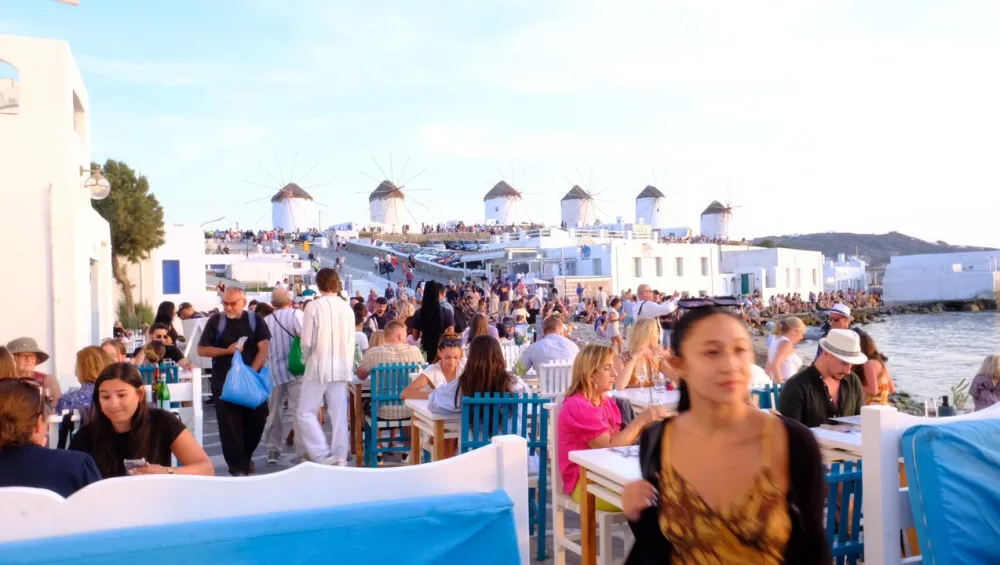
[363,363,420,467]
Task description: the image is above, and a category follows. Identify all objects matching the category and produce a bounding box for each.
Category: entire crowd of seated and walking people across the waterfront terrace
[0,249,1000,564]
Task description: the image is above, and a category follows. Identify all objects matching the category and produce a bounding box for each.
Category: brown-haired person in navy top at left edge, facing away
[0,377,101,497]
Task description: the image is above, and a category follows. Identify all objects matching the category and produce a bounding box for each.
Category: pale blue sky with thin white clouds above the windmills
[0,0,1000,247]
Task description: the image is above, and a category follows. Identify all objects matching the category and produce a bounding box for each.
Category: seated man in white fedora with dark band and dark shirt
[778,329,868,428]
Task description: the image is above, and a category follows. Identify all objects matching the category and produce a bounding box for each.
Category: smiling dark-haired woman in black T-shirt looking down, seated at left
[69,363,215,478]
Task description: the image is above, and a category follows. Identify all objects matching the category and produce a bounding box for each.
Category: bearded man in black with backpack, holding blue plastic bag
[198,287,271,477]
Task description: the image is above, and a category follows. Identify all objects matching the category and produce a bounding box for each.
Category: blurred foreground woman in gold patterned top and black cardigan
[621,307,833,565]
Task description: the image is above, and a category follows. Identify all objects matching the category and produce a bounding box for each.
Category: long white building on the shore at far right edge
[882,251,1000,305]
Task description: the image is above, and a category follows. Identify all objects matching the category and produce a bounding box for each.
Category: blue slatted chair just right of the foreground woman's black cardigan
[826,461,865,565]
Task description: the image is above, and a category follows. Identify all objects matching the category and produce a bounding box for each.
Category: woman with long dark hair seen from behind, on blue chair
[428,335,531,414]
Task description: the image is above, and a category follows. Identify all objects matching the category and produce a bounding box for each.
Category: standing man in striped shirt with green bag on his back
[263,288,302,463]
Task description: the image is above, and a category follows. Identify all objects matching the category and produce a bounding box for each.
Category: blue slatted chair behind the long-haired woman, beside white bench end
[459,393,552,561]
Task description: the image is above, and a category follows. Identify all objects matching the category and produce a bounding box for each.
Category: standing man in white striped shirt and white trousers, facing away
[295,268,355,465]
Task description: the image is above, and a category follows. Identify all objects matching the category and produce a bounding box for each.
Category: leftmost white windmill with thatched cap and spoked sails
[243,151,330,233]
